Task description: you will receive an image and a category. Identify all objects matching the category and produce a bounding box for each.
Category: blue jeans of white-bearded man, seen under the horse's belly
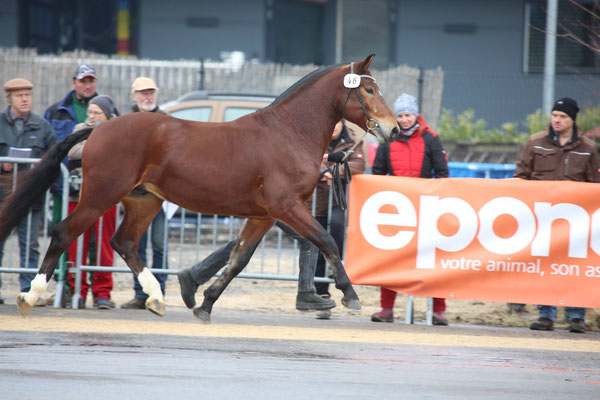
[133,208,169,300]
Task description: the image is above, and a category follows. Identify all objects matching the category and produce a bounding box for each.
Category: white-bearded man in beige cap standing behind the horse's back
[121,76,169,310]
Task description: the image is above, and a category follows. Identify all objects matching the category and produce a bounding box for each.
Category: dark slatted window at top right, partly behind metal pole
[523,0,600,73]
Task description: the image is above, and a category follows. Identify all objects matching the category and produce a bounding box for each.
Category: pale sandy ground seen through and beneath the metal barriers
[0,226,600,331]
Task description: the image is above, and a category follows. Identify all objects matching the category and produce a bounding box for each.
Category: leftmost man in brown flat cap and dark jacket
[0,78,56,305]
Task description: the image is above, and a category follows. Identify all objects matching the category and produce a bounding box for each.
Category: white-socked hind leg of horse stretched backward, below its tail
[17,206,104,315]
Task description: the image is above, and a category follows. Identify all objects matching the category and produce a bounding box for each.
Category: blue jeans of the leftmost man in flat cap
[0,210,43,292]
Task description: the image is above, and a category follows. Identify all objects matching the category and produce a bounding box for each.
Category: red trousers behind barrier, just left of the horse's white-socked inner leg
[68,201,117,299]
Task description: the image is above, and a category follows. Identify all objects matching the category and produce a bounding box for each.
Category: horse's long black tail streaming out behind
[0,128,93,242]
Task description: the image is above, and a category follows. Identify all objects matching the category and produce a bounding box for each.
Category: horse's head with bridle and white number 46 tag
[338,54,400,143]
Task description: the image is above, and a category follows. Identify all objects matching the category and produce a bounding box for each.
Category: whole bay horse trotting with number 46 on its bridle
[0,54,398,322]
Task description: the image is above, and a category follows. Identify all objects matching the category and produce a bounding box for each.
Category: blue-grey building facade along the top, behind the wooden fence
[0,0,600,127]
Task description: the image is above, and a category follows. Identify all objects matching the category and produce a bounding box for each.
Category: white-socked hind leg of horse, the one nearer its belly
[110,190,165,317]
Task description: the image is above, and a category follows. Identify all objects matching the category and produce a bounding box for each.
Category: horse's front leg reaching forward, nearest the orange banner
[279,204,360,310]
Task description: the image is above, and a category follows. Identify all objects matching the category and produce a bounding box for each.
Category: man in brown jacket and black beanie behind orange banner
[515,97,600,333]
